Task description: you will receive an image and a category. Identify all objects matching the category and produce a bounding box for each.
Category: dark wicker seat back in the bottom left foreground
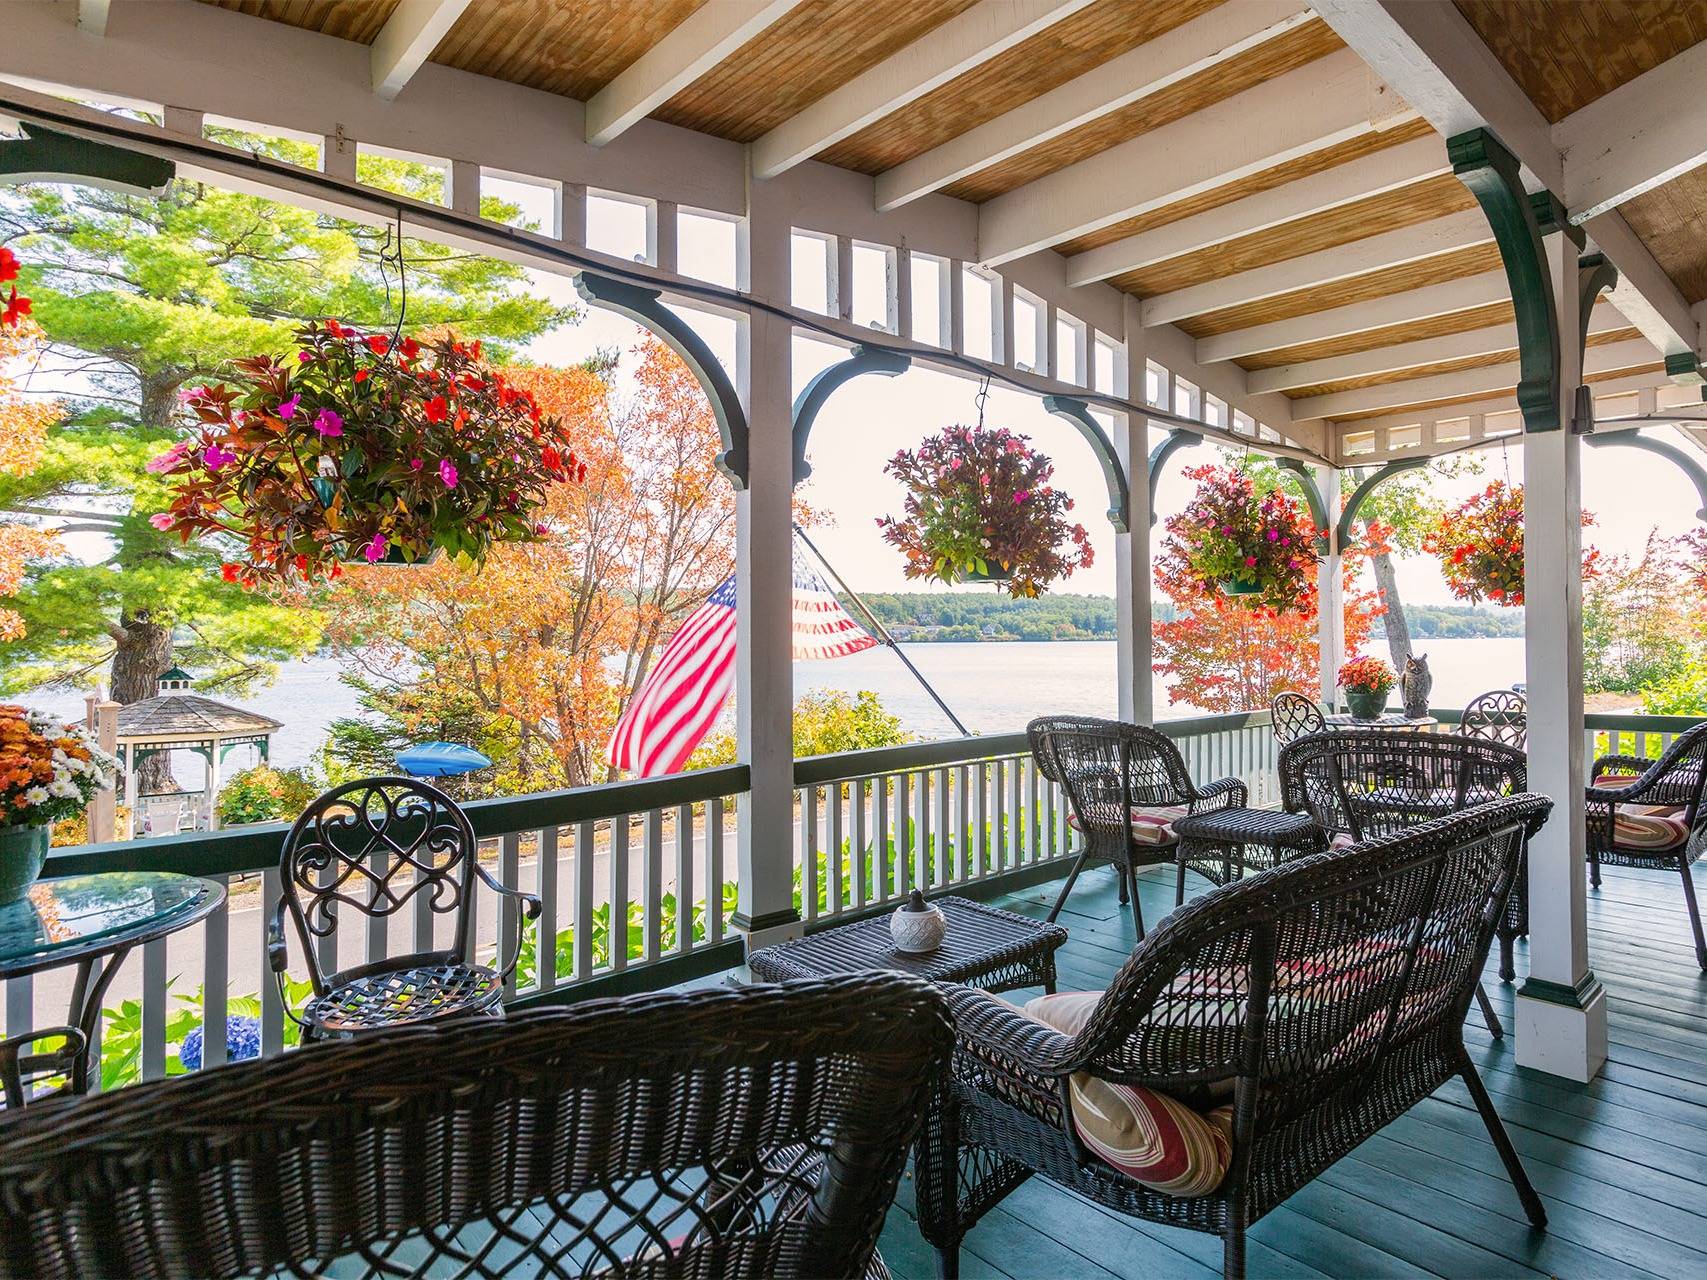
[0,975,953,1280]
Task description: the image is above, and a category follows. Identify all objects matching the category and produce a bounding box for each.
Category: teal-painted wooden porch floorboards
[883,869,1707,1280]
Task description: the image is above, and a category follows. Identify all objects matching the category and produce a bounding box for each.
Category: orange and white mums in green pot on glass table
[0,707,116,906]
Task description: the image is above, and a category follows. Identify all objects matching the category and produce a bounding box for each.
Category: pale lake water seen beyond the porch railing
[22,637,1523,768]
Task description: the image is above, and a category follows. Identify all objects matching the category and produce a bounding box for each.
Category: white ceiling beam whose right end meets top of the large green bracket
[1067,133,1453,285]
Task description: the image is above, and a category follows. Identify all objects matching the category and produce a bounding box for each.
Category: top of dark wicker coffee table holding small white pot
[748,898,1067,992]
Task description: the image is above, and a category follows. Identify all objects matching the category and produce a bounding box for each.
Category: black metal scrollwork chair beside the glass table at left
[266,778,539,1039]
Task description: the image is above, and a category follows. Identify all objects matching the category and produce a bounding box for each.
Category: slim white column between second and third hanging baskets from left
[1115,295,1156,724]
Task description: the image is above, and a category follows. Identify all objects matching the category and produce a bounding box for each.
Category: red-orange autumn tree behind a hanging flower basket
[1154,469,1386,723]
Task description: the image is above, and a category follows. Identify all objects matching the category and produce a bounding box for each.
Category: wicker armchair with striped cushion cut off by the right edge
[1586,724,1707,969]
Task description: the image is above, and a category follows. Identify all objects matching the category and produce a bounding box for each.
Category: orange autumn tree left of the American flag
[329,338,734,792]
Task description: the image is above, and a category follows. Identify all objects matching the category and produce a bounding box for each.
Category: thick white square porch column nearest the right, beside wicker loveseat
[1516,234,1606,1080]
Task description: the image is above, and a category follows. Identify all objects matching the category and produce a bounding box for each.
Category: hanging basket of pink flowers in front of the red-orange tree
[1168,466,1321,613]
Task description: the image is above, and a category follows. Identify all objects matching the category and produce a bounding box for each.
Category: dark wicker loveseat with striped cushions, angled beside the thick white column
[913,795,1552,1277]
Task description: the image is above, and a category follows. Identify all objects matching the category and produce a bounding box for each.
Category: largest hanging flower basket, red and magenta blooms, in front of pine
[149,321,586,585]
